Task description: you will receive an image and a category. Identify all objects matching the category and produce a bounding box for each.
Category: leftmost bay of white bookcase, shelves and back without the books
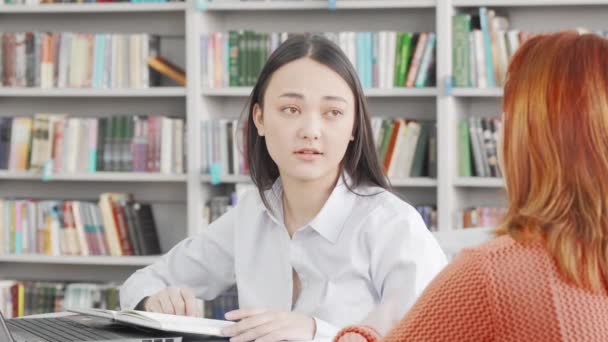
[0,2,190,282]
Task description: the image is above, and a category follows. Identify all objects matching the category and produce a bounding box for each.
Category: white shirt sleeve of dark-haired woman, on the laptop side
[120,204,236,309]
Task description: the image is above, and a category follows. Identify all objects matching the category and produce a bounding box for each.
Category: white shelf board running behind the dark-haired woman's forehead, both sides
[201,87,437,97]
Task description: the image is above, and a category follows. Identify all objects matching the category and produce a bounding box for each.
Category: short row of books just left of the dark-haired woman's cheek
[201,119,249,175]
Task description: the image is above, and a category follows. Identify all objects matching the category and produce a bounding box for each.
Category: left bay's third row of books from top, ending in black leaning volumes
[0,193,161,256]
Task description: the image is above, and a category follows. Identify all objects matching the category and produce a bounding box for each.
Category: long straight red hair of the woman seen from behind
[499,32,608,291]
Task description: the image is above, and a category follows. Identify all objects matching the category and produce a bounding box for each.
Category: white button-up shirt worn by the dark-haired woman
[120,177,446,338]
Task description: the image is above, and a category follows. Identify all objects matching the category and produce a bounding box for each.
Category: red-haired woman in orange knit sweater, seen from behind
[337,32,608,342]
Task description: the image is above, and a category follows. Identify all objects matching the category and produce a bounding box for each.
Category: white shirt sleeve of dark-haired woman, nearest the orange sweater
[363,206,447,335]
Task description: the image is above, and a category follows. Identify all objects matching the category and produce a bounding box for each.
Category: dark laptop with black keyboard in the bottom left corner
[0,312,185,342]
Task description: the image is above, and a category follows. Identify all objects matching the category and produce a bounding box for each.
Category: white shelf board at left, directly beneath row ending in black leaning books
[0,254,159,267]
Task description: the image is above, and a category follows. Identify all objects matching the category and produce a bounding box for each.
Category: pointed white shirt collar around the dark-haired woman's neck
[262,173,357,243]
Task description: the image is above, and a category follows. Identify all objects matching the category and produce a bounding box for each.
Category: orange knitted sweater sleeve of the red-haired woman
[385,250,494,341]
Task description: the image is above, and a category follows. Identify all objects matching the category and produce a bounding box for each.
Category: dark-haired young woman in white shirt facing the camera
[120,36,446,342]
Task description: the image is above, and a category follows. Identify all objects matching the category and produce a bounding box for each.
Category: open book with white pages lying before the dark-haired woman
[67,309,234,336]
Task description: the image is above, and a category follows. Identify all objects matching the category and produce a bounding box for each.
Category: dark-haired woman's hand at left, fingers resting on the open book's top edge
[144,287,202,317]
